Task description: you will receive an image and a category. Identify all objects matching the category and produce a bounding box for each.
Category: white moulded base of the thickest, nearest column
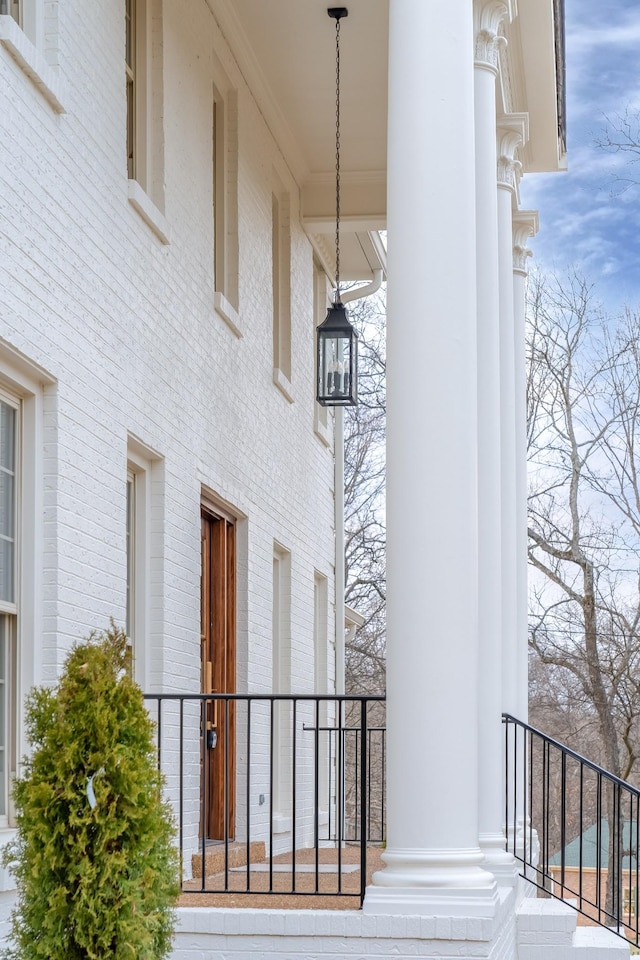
[362,849,498,919]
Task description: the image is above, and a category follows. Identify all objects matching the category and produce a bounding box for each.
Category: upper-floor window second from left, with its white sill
[125,0,169,243]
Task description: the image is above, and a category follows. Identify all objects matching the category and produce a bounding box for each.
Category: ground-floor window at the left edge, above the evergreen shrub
[0,393,20,826]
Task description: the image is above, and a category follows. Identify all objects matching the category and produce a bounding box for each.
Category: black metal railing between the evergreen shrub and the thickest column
[145,694,386,902]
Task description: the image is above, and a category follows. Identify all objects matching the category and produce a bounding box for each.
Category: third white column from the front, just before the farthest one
[498,114,527,715]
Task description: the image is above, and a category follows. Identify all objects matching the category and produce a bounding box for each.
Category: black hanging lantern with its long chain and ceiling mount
[317,7,358,407]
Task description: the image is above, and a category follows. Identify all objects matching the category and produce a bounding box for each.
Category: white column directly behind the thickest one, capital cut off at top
[474,0,516,884]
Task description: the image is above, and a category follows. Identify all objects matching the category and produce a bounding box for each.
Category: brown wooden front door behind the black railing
[200,509,236,840]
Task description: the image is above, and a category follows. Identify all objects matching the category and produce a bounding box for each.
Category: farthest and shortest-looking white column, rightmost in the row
[513,210,538,722]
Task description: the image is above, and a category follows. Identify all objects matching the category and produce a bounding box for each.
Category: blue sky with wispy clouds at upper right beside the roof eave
[521,0,640,311]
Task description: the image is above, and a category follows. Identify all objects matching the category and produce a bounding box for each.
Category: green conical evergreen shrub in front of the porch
[5,623,179,960]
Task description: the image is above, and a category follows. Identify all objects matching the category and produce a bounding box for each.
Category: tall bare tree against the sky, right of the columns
[527,273,640,909]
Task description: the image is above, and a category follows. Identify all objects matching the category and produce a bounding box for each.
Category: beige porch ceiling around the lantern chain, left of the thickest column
[209,0,389,280]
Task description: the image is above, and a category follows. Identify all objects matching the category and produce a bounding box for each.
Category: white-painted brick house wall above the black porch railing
[0,0,334,908]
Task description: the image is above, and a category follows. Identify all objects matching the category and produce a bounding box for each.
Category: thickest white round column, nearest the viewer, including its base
[364,0,497,917]
